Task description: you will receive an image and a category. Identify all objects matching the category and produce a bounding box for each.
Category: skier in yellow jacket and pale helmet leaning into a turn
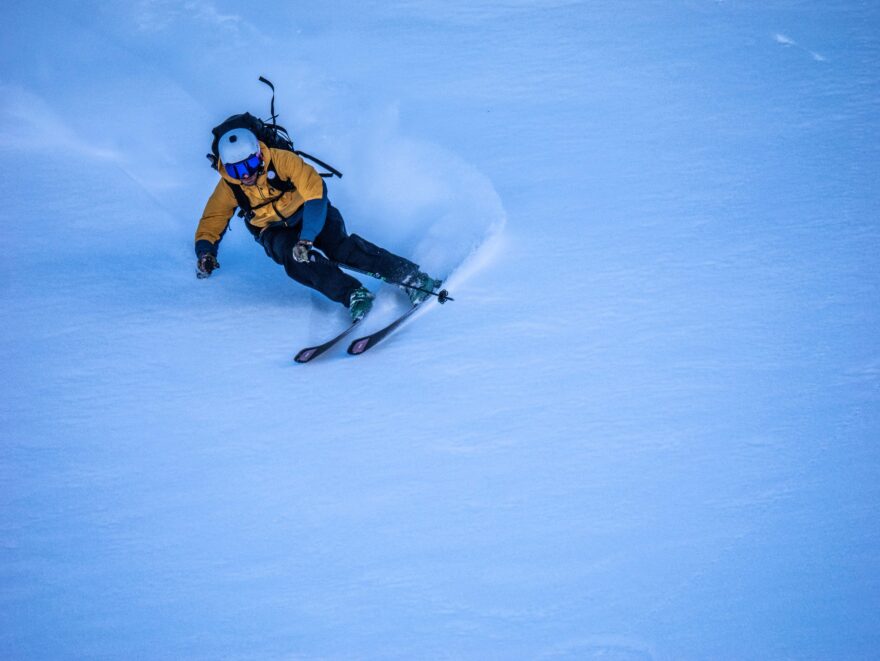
[195,128,441,321]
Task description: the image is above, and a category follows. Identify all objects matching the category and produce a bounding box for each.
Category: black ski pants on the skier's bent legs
[247,204,419,307]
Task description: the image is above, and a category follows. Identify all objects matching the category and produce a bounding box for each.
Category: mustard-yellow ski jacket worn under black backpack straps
[196,142,324,251]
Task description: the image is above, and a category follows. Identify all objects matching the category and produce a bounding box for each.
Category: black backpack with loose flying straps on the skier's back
[206,76,342,220]
